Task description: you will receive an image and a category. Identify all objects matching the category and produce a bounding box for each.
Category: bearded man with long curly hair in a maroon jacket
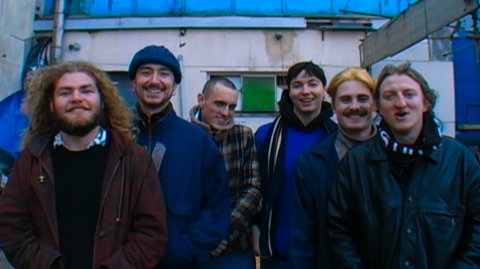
[0,62,167,269]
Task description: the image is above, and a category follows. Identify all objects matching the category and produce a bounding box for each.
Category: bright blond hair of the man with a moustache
[327,67,376,105]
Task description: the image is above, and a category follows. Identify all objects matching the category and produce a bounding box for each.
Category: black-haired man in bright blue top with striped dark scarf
[253,61,337,269]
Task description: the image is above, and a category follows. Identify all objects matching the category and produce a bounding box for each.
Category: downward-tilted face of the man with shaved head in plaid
[197,83,238,130]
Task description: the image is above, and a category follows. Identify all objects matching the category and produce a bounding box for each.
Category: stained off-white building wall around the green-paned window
[62,30,364,129]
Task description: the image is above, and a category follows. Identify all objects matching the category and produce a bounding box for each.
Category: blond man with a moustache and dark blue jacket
[289,68,377,269]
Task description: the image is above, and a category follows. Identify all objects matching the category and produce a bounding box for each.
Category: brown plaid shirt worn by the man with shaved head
[190,108,262,251]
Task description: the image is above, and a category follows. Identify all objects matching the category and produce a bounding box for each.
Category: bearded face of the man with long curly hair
[50,72,102,137]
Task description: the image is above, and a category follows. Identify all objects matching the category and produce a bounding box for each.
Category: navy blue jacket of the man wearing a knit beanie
[137,110,230,269]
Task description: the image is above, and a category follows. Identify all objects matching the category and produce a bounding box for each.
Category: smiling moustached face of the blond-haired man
[334,80,375,132]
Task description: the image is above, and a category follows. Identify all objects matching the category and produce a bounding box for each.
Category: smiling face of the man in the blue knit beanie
[132,64,177,112]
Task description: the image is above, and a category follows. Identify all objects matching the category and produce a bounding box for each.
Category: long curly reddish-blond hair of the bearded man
[22,61,134,149]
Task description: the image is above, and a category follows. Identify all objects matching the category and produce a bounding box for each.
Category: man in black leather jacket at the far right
[328,63,480,269]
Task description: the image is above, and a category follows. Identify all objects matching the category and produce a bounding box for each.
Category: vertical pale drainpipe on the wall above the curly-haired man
[51,0,65,64]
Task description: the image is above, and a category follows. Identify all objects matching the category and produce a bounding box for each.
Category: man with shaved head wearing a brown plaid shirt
[190,77,262,269]
